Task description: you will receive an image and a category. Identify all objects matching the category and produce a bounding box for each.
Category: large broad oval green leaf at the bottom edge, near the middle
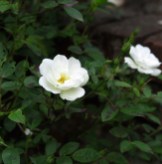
[72,148,100,163]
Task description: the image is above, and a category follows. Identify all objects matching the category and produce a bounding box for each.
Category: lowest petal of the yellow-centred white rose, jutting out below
[60,88,85,101]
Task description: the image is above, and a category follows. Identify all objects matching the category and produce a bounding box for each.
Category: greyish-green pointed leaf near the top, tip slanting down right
[64,7,83,22]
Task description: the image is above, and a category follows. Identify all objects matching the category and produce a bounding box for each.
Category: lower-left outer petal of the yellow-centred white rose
[39,76,60,94]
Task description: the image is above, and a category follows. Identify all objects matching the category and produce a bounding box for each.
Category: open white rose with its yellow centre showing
[39,54,89,101]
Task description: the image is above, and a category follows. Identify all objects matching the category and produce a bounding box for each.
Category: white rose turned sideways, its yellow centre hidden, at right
[124,44,161,76]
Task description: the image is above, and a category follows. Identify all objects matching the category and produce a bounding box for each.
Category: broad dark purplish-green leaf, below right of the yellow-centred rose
[101,106,118,122]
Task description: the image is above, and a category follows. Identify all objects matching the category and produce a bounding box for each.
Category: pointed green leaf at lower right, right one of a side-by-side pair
[132,141,152,153]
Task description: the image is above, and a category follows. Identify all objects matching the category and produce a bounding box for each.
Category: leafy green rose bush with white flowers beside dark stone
[0,0,162,164]
